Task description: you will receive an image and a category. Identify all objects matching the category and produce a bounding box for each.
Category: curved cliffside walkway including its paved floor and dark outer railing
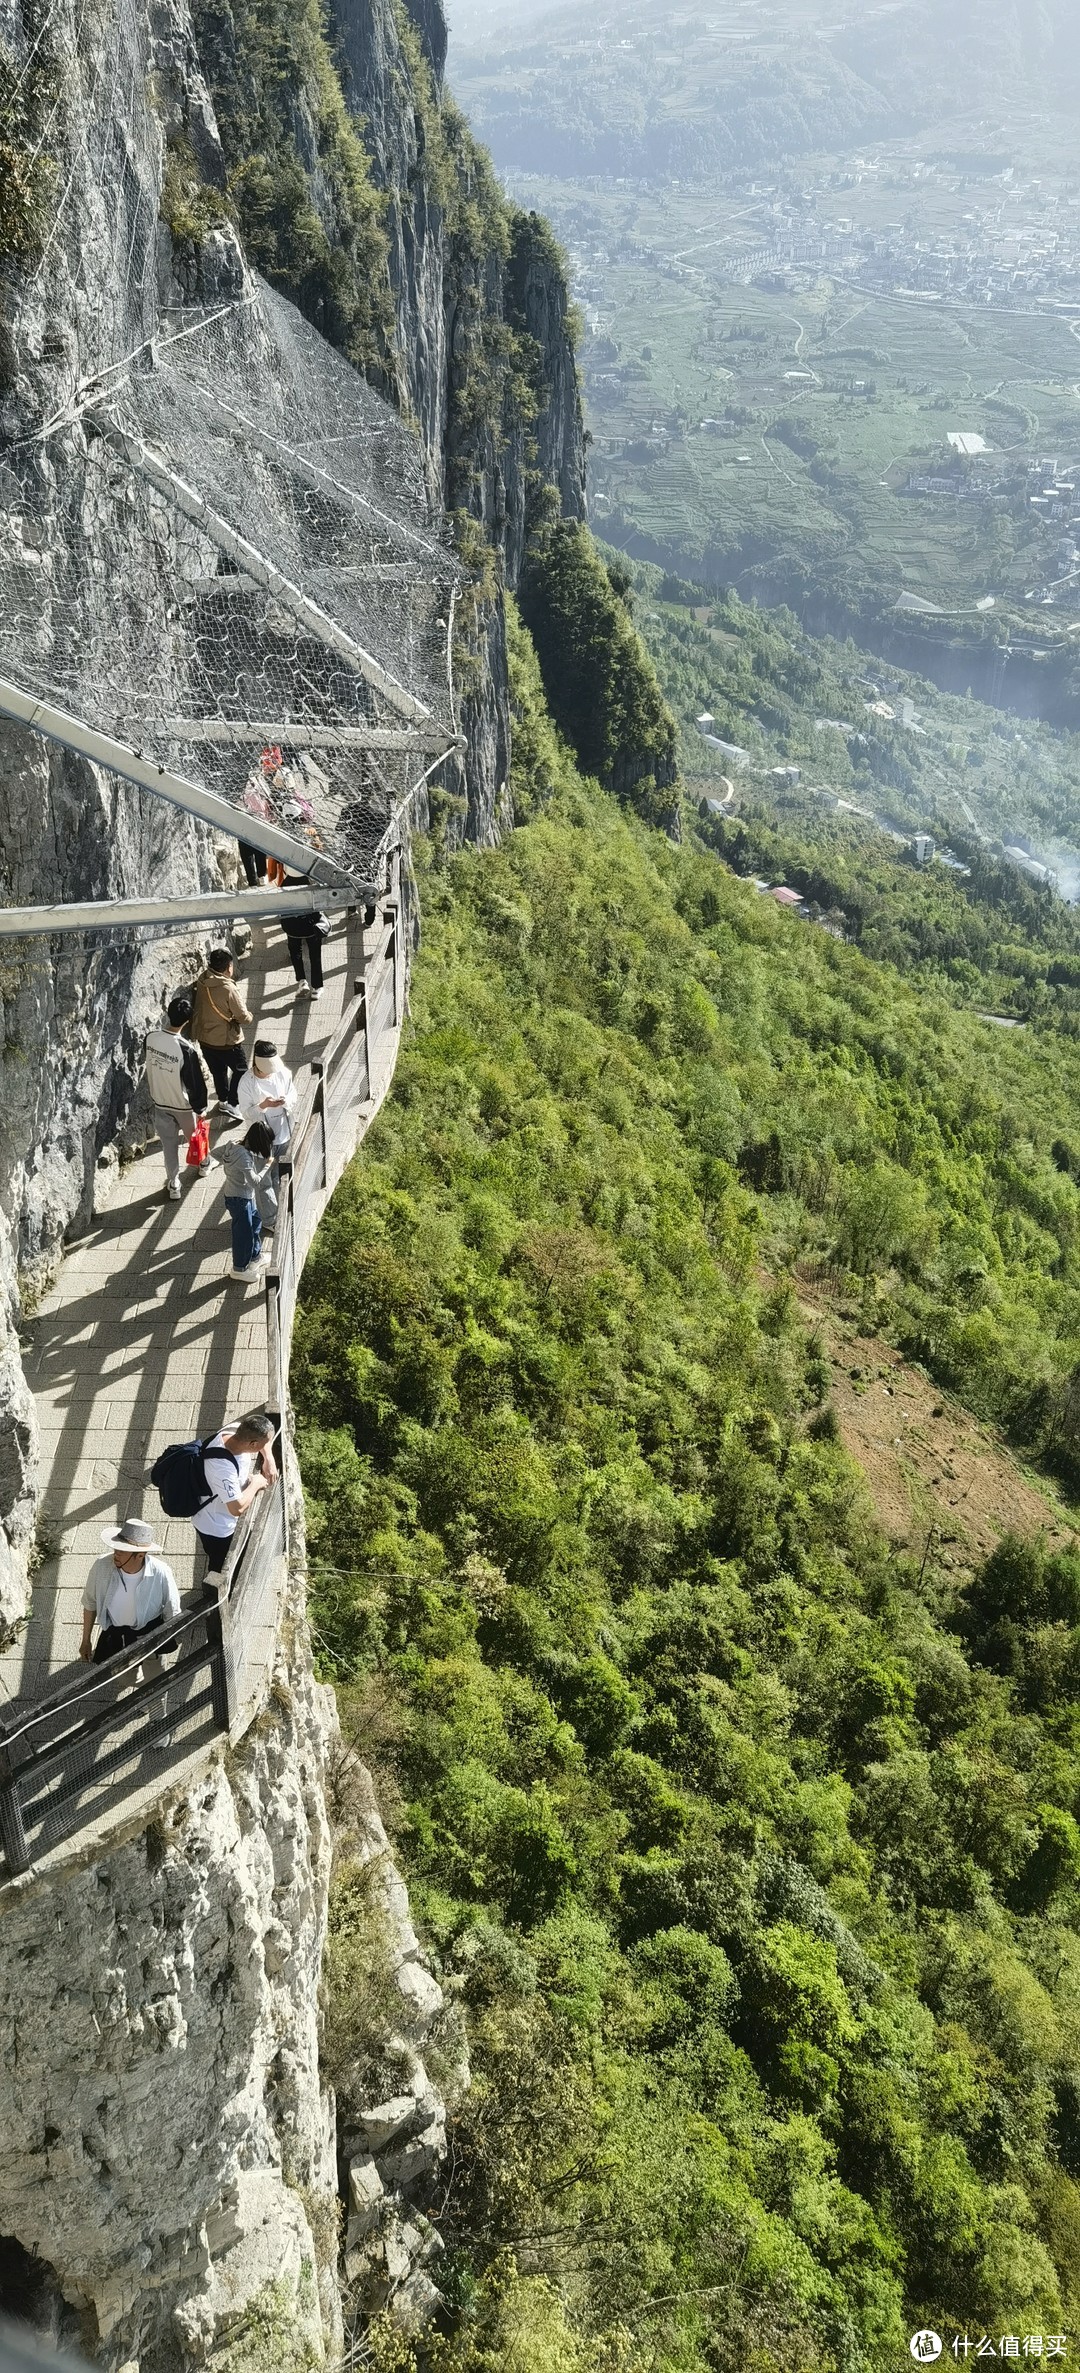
[0,850,406,1889]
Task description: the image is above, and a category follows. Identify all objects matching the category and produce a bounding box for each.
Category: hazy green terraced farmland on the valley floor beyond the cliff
[529,185,1080,631]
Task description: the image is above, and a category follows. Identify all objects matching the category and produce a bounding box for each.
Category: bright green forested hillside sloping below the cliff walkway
[294,602,1080,2373]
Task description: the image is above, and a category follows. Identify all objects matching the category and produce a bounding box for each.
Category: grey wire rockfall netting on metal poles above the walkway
[0,282,458,880]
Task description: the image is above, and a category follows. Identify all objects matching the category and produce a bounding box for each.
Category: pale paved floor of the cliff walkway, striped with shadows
[0,901,361,1704]
